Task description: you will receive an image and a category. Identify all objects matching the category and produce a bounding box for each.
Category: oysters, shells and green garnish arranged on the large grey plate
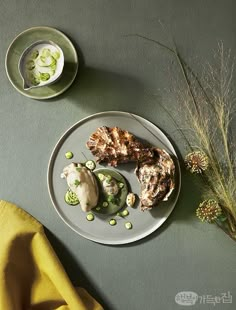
[61,126,175,229]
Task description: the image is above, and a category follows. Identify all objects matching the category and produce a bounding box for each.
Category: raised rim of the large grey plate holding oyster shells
[47,111,182,245]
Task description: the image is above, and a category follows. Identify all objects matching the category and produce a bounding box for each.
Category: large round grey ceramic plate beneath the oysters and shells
[48,112,181,244]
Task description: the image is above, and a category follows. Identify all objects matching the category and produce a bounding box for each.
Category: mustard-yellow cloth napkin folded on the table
[0,201,103,310]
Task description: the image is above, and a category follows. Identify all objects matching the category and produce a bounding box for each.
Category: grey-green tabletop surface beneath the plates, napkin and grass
[0,0,236,310]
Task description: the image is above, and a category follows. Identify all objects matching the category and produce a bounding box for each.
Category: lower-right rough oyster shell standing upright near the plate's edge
[135,148,175,210]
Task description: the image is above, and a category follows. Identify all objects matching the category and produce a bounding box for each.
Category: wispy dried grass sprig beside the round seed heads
[129,34,236,241]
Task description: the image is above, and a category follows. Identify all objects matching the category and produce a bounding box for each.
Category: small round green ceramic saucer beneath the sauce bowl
[5,27,79,100]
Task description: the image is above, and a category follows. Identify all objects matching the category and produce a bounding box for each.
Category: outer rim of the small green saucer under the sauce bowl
[5,26,79,100]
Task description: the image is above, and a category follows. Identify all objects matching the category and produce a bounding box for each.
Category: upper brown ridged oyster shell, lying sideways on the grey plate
[86,126,153,167]
